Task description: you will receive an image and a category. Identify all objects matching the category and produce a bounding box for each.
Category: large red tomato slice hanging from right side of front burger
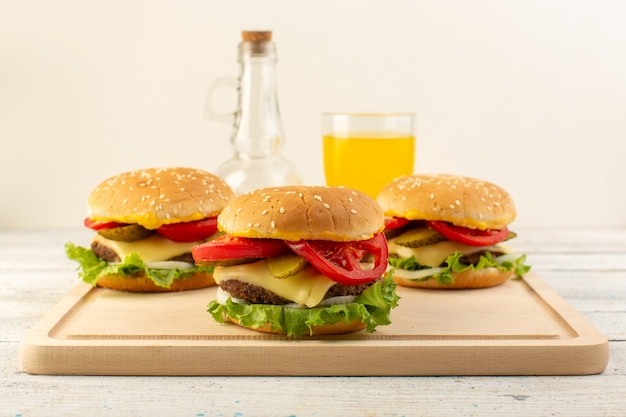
[286,233,388,285]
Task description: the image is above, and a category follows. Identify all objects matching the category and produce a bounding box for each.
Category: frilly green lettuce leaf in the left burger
[65,242,213,288]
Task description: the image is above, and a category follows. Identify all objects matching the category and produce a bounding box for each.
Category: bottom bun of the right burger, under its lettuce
[393,268,515,289]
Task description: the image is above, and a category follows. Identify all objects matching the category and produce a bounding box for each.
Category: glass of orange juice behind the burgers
[322,113,416,198]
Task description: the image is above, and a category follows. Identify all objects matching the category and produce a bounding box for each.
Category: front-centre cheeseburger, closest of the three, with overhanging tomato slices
[192,186,398,337]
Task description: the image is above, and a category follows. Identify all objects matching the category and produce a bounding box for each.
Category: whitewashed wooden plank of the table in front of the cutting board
[0,343,626,417]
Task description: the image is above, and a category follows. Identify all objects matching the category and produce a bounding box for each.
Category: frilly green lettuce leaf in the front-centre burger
[207,274,400,337]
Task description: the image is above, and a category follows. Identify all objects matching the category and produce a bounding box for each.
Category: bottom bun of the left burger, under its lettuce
[96,272,215,292]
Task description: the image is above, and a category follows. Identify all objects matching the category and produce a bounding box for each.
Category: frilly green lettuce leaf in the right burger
[389,252,530,284]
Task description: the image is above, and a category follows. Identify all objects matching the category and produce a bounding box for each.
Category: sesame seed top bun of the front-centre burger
[217,186,385,242]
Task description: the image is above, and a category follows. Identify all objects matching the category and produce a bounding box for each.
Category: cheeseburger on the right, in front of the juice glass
[377,174,530,288]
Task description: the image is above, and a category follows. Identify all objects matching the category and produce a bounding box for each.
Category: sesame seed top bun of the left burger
[87,167,234,229]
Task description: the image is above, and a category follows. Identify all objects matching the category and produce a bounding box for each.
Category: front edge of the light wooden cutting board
[18,345,608,376]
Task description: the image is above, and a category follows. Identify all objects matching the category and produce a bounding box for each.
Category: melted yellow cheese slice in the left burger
[93,234,200,262]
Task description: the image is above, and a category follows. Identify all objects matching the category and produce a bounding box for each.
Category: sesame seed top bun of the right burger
[377,174,517,230]
